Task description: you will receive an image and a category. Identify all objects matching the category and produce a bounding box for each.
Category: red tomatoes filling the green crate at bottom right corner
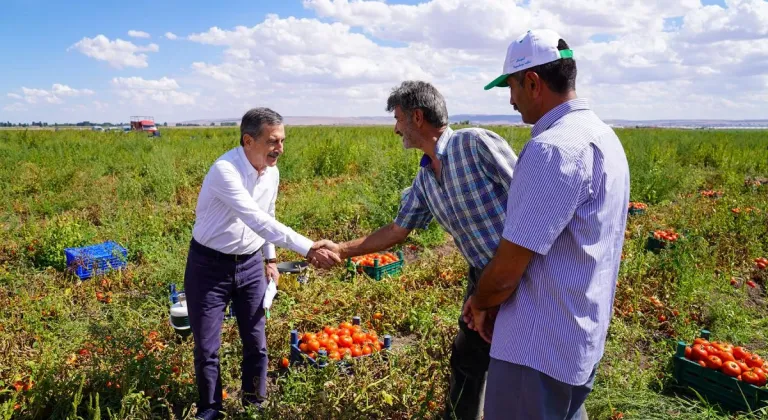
[685,338,768,386]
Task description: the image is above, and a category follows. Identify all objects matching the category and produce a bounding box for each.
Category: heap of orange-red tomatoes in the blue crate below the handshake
[299,322,384,360]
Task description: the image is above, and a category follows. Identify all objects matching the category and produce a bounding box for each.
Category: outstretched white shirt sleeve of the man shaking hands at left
[206,160,314,256]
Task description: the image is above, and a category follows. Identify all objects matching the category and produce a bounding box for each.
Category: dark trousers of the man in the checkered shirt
[444,267,491,420]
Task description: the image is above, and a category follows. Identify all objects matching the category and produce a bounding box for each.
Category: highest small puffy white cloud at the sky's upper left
[67,35,160,69]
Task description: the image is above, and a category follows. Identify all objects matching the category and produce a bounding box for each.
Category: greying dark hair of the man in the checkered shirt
[387,80,448,128]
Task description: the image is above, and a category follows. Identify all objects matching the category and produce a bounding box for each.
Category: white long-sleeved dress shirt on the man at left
[192,146,314,258]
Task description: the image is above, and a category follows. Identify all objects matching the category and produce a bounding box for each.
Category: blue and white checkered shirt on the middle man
[395,128,517,268]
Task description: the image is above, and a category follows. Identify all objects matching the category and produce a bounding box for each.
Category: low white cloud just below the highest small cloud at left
[112,77,197,105]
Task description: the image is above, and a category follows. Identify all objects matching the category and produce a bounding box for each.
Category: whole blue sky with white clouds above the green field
[0,0,768,122]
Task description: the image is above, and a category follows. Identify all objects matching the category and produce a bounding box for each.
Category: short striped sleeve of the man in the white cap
[502,142,587,255]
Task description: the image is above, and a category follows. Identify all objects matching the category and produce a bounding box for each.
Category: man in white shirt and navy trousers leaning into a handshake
[184,108,340,420]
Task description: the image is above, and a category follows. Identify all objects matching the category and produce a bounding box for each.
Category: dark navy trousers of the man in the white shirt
[184,239,268,410]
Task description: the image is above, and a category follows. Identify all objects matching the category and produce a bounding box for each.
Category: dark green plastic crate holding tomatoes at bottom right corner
[673,330,768,411]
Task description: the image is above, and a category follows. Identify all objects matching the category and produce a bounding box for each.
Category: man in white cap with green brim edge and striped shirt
[470,30,629,420]
